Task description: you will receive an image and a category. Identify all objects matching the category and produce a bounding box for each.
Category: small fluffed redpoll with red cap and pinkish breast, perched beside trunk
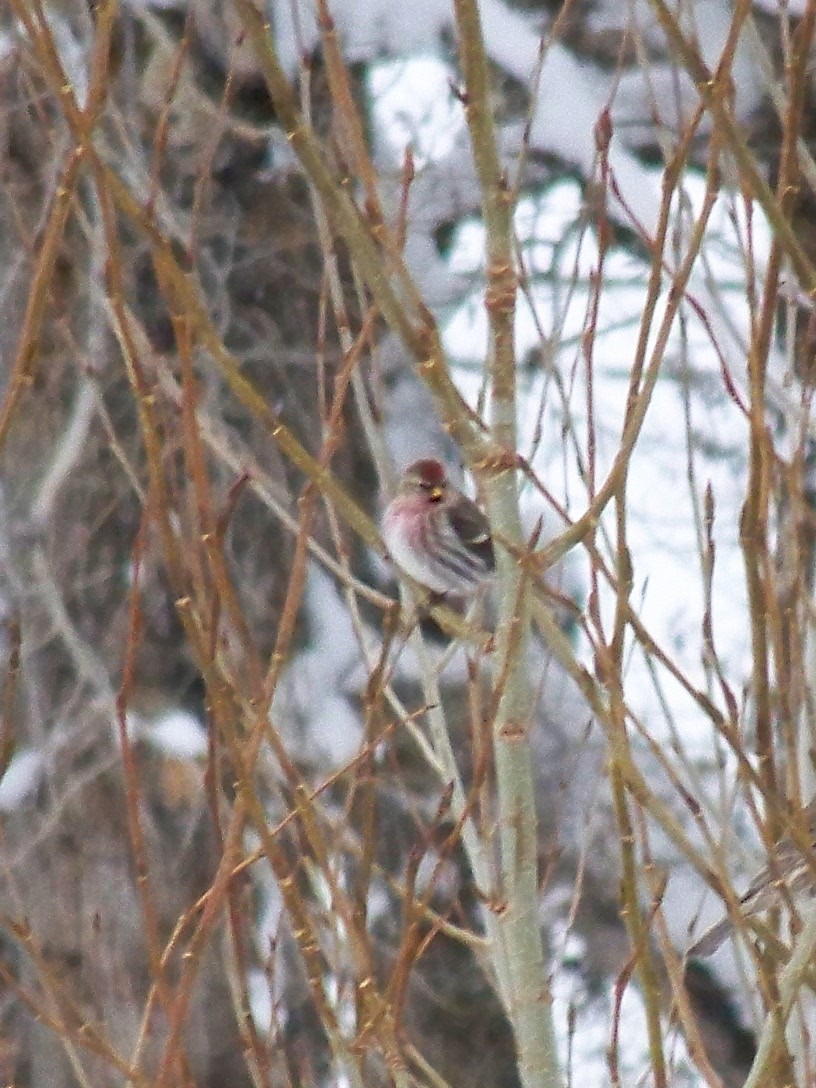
[382,457,495,596]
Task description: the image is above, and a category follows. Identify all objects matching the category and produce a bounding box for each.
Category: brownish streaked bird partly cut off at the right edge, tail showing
[687,799,816,959]
